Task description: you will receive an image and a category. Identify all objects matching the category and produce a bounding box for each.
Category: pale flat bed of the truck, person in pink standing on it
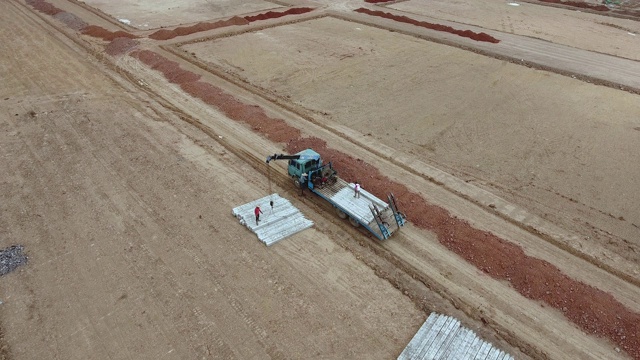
[312,178,398,239]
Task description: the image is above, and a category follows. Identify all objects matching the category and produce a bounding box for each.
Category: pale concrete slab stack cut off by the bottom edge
[398,313,513,360]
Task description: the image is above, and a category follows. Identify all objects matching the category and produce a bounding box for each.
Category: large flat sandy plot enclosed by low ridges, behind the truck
[182,13,640,260]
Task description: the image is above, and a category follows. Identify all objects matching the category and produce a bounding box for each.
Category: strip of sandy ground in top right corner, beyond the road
[388,0,640,60]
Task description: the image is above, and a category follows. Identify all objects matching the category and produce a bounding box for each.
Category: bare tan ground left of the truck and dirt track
[0,2,424,359]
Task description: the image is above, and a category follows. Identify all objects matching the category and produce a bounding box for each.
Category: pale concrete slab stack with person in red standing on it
[233,194,313,246]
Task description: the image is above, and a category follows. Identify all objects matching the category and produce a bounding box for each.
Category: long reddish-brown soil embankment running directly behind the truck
[132,50,640,359]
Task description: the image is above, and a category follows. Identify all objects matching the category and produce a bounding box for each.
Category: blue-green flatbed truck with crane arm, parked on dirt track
[267,149,406,240]
